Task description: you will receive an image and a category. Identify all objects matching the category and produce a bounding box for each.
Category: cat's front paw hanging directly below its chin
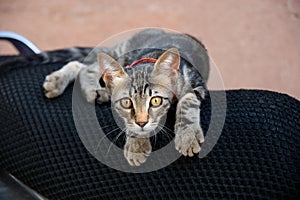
[124,138,152,166]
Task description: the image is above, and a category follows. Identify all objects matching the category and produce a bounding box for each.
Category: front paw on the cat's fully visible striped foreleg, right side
[175,127,204,157]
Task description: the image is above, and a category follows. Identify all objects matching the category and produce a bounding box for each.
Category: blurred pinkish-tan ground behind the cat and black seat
[0,0,300,99]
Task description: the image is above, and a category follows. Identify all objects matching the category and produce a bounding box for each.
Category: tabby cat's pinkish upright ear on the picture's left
[98,53,127,89]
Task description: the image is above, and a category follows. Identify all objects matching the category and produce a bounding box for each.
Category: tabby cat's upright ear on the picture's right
[153,48,180,79]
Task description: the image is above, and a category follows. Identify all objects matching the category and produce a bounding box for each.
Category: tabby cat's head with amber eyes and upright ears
[98,48,180,137]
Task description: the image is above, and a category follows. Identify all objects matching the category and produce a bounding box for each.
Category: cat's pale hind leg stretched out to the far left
[43,61,86,98]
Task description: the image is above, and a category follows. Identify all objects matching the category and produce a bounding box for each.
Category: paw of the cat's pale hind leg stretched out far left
[43,71,68,98]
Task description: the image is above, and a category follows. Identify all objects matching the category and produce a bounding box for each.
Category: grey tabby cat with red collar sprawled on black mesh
[43,29,209,166]
